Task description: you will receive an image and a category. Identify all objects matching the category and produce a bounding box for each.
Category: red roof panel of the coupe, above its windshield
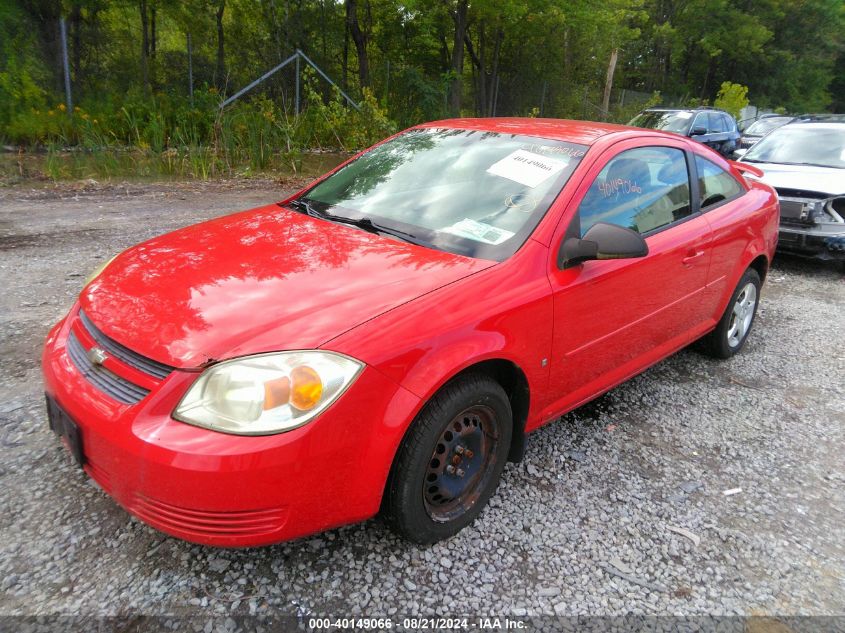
[415,117,644,145]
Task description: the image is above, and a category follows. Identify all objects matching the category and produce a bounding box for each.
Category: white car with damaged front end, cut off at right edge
[742,115,845,261]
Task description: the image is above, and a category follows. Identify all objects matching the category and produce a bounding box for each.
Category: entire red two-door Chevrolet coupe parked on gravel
[43,119,778,546]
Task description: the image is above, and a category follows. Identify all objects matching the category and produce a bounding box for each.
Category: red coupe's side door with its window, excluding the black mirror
[545,139,711,416]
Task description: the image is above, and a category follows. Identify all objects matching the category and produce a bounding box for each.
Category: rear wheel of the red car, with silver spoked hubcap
[702,268,762,358]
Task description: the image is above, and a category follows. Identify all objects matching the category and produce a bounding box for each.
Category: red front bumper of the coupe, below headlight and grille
[42,308,420,547]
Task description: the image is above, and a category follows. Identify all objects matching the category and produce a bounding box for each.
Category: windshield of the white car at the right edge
[743,123,845,169]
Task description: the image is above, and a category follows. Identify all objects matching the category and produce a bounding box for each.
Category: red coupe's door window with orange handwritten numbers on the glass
[578,147,691,236]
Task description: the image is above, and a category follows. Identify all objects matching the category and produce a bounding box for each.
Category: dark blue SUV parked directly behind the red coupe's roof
[628,107,739,156]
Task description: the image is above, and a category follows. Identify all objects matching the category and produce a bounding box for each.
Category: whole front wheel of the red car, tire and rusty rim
[385,374,513,545]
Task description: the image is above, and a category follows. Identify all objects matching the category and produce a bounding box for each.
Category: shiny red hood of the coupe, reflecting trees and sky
[80,205,495,368]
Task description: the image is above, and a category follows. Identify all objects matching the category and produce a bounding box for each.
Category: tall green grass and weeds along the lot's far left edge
[0,75,396,180]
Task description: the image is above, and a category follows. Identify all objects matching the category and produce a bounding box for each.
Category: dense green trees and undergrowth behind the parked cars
[0,0,845,177]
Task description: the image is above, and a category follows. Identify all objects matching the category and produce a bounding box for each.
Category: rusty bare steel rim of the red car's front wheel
[423,405,499,523]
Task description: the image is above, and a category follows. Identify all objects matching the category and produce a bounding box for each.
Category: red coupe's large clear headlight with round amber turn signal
[173,351,364,435]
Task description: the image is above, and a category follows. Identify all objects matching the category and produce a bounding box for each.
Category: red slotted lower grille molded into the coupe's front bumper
[129,495,287,537]
